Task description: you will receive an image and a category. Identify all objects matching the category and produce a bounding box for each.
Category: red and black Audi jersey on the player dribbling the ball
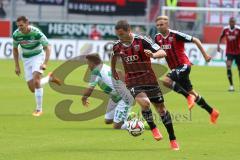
[113,34,160,87]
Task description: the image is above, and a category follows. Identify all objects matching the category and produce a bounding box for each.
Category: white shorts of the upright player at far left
[22,52,45,82]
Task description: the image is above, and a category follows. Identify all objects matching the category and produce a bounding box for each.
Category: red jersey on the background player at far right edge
[222,25,240,55]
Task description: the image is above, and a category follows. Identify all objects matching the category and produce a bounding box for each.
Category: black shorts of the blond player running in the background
[167,65,193,92]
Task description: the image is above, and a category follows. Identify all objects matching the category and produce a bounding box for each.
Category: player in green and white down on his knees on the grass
[82,54,134,129]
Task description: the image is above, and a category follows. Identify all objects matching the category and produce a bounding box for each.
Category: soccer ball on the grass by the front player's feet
[127,119,144,137]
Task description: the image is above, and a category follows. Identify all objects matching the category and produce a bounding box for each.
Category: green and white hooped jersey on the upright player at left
[13,26,49,58]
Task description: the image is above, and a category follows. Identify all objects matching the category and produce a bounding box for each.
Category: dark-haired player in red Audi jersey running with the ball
[111,20,179,150]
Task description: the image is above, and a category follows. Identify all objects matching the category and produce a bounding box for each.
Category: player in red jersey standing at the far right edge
[217,17,240,92]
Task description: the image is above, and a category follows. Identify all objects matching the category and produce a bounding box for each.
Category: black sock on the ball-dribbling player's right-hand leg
[160,111,176,140]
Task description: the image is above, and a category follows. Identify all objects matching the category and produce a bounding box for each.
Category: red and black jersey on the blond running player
[155,29,192,69]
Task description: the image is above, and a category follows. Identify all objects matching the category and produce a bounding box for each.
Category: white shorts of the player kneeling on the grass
[105,99,131,123]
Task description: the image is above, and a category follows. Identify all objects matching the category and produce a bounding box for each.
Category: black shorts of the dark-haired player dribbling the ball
[128,85,164,103]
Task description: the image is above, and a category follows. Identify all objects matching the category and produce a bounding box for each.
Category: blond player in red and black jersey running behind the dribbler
[155,16,219,123]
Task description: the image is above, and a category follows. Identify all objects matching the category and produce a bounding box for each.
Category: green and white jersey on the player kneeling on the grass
[89,64,122,103]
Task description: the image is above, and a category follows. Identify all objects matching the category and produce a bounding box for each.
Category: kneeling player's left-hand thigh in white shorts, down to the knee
[105,98,117,124]
